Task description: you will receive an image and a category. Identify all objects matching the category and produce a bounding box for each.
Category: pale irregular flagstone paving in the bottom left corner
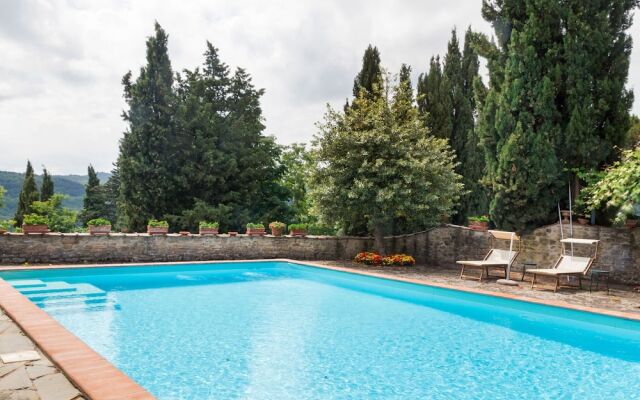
[0,311,85,400]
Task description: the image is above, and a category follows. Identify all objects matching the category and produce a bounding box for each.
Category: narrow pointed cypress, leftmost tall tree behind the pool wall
[118,22,178,230]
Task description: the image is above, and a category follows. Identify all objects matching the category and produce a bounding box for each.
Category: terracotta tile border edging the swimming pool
[0,258,640,400]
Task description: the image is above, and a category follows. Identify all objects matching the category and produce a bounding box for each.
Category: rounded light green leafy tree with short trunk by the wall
[312,73,462,253]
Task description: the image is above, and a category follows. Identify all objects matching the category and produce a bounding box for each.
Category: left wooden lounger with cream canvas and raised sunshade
[457,231,520,282]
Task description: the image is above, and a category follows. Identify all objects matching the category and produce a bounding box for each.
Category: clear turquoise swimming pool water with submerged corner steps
[0,262,640,400]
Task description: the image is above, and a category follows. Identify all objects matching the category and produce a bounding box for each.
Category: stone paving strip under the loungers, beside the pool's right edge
[315,261,640,316]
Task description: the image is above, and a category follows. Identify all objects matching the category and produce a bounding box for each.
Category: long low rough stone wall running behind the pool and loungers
[0,224,640,284]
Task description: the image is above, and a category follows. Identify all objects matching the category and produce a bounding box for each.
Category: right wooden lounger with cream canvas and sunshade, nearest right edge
[527,238,599,292]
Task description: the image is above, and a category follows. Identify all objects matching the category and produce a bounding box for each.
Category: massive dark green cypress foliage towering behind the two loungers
[472,0,637,230]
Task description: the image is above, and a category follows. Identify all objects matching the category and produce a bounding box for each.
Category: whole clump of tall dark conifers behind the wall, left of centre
[118,25,288,230]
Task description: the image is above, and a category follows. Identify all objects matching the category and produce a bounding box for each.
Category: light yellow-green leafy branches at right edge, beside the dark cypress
[586,147,640,223]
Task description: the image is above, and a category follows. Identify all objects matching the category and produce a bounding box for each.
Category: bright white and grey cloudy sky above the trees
[0,0,640,173]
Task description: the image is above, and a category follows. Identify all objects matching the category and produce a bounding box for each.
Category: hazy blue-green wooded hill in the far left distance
[0,171,111,219]
